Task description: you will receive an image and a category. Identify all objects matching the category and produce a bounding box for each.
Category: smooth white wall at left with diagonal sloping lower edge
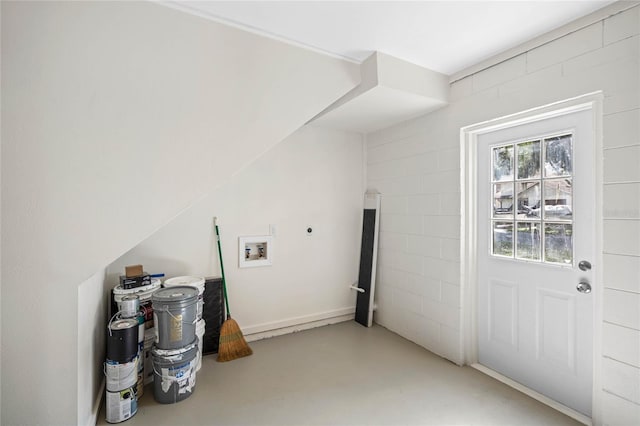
[0,1,359,424]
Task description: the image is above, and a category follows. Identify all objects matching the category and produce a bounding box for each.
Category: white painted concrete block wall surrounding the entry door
[367,6,640,425]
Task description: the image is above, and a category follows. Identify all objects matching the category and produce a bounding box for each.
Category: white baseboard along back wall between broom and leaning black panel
[242,307,355,342]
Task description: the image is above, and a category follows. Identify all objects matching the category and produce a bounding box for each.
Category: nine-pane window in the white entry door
[489,133,573,265]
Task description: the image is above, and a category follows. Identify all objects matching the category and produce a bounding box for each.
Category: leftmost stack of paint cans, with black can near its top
[104,296,141,423]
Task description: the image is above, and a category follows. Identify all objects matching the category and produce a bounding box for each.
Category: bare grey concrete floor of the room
[98,322,579,426]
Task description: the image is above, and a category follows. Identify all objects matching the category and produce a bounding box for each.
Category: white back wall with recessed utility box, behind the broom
[108,126,364,340]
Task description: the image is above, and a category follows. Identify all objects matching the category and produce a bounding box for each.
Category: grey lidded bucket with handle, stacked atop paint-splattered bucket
[151,286,198,349]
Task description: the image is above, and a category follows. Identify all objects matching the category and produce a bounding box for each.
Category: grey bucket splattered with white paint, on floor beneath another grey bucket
[151,342,198,404]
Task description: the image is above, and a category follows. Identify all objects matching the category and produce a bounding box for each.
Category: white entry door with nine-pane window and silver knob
[476,110,595,417]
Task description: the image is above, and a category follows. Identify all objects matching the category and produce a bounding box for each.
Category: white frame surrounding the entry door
[460,92,604,425]
